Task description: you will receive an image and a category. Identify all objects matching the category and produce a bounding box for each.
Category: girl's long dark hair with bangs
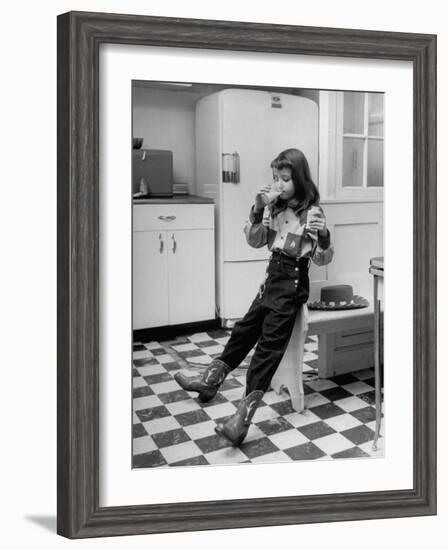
[271,149,320,214]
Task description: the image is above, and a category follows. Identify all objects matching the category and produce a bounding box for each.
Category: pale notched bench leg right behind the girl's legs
[271,304,309,412]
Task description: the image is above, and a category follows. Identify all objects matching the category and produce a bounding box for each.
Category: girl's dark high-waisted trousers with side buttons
[220,253,309,395]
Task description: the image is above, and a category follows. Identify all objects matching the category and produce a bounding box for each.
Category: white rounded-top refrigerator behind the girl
[195,89,319,328]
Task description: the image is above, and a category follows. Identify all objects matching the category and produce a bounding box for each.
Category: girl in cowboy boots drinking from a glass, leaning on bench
[174,149,334,446]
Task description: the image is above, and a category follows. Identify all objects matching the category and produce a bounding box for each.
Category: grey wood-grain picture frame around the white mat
[57,12,436,538]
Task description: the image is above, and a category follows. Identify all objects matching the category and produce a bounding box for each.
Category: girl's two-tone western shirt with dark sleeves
[244,204,334,266]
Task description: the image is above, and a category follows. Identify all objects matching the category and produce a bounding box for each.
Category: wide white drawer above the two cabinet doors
[132,204,214,231]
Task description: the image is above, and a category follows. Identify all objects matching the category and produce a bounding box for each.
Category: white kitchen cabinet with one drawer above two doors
[133,203,215,330]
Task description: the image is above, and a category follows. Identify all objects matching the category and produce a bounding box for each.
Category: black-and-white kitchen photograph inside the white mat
[129,80,387,469]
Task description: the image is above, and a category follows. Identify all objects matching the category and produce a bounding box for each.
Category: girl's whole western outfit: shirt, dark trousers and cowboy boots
[174,199,334,445]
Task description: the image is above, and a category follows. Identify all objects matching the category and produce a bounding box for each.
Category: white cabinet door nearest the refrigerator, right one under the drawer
[167,229,215,325]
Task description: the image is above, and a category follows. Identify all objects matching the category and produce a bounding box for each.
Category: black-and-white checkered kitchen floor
[133,330,384,468]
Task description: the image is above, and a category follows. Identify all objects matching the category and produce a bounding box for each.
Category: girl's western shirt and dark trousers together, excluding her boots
[220,201,334,394]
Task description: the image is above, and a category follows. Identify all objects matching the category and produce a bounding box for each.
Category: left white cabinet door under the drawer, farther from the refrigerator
[132,231,169,330]
